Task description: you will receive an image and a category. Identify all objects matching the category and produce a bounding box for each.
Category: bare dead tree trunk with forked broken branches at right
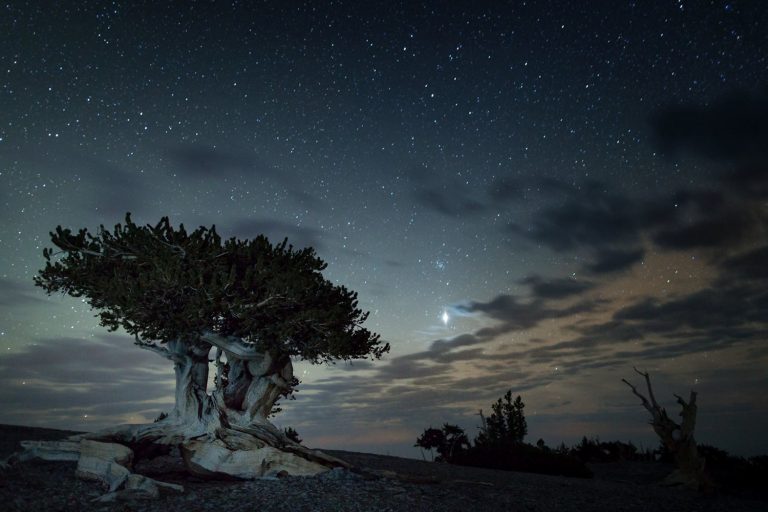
[621,368,711,490]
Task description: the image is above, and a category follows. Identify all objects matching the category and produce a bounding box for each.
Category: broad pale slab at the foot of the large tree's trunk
[182,440,329,479]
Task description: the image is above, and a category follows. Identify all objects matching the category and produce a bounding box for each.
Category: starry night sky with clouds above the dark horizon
[0,0,768,457]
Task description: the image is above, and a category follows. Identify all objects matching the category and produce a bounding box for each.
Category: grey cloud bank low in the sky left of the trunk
[0,334,174,428]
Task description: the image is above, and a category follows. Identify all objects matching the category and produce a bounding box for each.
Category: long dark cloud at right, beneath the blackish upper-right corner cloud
[507,170,768,274]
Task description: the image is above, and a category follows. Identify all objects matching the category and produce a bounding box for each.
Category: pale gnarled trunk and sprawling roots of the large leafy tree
[1,333,349,492]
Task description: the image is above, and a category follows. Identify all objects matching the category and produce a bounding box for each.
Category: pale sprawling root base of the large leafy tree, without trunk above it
[0,422,351,501]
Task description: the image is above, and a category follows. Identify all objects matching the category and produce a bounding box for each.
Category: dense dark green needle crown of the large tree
[35,213,389,363]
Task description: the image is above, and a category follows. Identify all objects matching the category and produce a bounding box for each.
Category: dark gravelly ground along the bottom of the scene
[0,425,768,512]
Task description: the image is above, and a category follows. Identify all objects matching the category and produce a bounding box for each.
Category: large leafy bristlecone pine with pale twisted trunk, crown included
[21,214,389,484]
